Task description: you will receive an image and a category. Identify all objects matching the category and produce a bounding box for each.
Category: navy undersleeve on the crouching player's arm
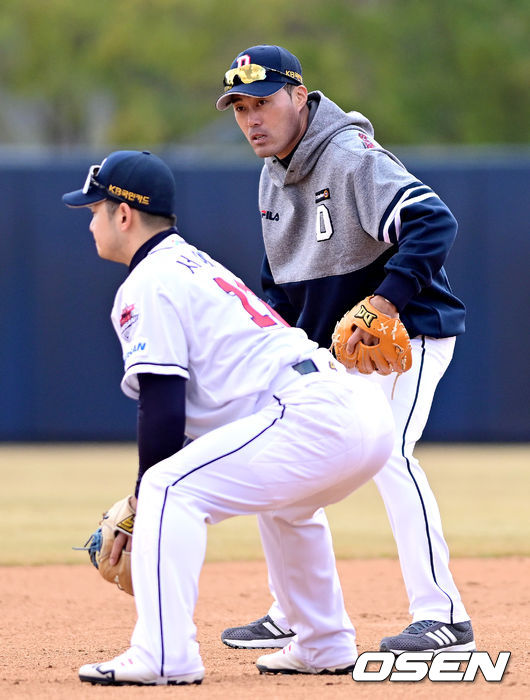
[134,374,186,496]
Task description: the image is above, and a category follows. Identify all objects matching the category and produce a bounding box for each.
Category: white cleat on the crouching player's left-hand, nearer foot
[79,650,204,685]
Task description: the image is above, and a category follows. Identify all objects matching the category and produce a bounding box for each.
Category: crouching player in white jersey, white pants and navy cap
[63,151,393,685]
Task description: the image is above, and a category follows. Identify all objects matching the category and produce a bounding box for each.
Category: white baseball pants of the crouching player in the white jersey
[127,368,393,676]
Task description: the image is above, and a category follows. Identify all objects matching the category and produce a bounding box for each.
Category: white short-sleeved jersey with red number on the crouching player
[112,233,317,438]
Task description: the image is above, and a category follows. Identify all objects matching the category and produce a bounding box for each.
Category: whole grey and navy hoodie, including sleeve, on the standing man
[259,92,465,344]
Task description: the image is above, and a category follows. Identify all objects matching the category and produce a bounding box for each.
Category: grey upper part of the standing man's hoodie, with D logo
[259,92,415,284]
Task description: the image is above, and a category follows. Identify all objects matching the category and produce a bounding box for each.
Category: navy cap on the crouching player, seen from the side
[62,151,177,217]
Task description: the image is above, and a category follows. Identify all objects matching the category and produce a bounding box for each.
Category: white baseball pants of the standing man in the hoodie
[268,337,469,633]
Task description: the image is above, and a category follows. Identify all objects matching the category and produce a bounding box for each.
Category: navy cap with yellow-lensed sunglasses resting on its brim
[215,44,302,111]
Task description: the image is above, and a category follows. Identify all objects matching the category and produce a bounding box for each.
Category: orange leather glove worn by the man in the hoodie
[331,297,412,374]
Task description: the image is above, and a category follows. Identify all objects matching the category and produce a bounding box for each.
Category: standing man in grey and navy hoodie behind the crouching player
[216,45,475,652]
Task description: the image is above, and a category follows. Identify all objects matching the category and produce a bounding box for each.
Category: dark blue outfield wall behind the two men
[0,154,530,441]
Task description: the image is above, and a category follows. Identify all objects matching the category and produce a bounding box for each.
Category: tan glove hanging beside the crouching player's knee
[79,496,136,595]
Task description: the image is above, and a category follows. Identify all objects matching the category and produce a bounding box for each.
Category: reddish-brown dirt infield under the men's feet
[0,558,530,700]
